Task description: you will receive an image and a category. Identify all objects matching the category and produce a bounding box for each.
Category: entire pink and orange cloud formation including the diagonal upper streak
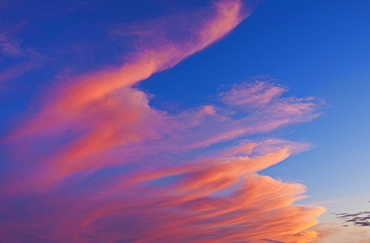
[0,0,324,242]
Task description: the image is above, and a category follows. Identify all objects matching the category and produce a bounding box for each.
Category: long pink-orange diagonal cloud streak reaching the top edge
[2,0,246,140]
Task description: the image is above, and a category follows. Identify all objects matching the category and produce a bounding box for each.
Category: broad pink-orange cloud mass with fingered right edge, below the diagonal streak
[0,78,323,242]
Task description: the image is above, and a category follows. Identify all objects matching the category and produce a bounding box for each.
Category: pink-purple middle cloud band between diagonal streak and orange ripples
[2,82,318,193]
